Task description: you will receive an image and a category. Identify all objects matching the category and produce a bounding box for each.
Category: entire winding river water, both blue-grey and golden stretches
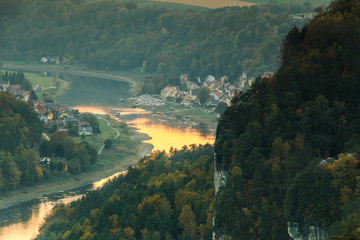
[0,74,214,240]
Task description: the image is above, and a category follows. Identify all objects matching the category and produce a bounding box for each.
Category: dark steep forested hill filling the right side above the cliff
[215,0,360,239]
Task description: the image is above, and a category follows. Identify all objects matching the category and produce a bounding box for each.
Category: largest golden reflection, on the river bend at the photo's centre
[129,118,215,151]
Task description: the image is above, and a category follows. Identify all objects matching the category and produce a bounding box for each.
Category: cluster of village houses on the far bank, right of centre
[161,73,253,106]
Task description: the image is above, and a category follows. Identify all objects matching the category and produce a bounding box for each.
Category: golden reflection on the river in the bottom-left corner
[0,195,82,240]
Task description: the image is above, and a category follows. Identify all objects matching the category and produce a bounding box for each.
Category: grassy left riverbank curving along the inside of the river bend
[0,115,153,209]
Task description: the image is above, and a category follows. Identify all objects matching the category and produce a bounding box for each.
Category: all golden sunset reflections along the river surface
[0,106,215,240]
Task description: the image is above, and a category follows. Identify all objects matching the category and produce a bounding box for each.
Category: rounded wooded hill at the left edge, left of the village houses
[0,91,43,191]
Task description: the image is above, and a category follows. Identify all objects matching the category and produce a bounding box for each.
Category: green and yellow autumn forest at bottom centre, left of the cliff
[37,145,214,240]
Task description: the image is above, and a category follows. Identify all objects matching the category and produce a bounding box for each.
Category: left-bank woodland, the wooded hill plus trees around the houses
[0,82,98,195]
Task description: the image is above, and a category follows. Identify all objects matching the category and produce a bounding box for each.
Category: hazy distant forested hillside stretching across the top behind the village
[0,0,308,93]
